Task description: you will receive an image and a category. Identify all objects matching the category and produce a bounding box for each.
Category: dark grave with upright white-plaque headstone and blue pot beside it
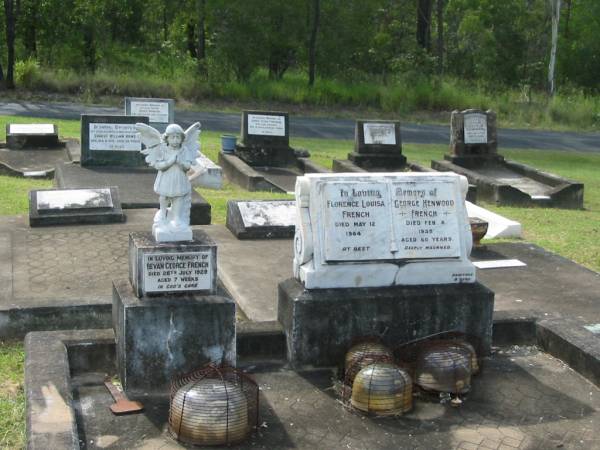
[219,111,327,192]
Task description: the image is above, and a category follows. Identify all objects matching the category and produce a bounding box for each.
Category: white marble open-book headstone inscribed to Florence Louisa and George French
[294,173,475,289]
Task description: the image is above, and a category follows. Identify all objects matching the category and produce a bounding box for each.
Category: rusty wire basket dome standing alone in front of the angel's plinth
[169,365,258,445]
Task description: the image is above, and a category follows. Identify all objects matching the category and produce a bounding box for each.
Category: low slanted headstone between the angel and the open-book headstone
[226,200,296,239]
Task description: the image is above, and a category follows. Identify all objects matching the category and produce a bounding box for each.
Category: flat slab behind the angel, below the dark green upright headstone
[54,164,211,225]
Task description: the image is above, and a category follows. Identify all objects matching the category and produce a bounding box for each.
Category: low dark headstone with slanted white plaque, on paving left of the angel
[29,187,125,227]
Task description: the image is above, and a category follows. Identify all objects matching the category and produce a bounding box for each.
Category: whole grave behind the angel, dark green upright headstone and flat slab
[55,115,210,225]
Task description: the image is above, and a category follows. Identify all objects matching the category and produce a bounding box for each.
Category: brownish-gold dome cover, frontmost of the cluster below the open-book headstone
[350,362,412,416]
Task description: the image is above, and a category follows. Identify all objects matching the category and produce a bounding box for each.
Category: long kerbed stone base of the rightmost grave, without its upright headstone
[431,155,583,209]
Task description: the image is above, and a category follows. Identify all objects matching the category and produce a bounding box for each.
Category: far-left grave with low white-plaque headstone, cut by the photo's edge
[0,123,79,178]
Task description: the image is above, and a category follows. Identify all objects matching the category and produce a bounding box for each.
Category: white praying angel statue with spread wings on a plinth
[135,122,200,242]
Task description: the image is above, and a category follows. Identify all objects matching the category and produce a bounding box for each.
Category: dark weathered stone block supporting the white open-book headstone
[278,278,494,367]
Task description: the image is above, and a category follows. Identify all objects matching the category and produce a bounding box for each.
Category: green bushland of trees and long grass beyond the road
[0,0,600,130]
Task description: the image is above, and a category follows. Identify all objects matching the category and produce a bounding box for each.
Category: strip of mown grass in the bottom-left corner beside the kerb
[0,342,25,449]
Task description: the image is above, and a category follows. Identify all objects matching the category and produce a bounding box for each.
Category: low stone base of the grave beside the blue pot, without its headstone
[219,152,329,192]
